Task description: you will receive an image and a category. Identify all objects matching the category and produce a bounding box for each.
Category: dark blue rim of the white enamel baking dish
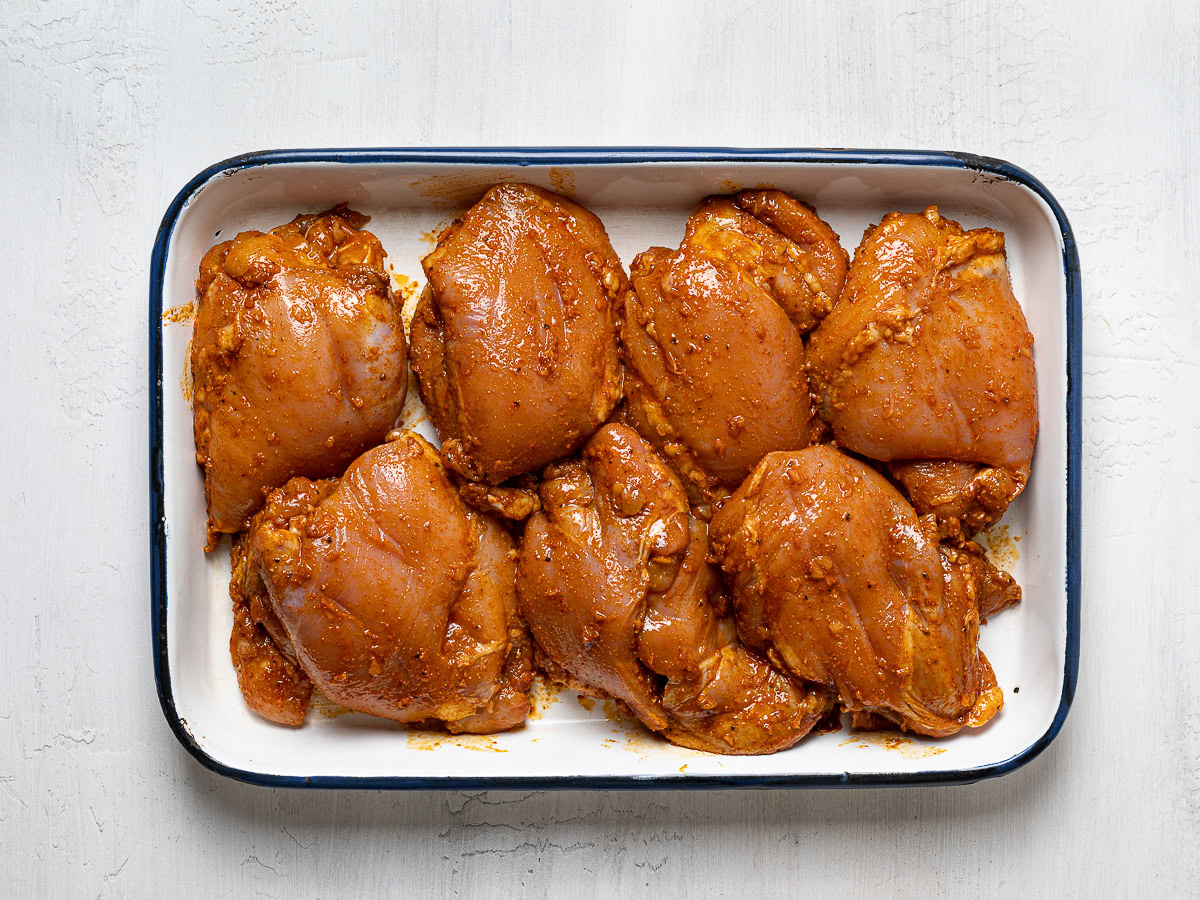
[150,148,1082,791]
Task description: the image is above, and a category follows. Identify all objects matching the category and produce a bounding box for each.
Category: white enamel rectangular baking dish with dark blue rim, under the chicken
[150,149,1081,788]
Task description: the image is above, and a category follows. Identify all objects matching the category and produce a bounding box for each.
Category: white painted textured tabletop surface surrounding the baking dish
[0,0,1200,898]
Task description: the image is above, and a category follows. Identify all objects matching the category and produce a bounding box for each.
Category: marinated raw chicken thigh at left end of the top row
[191,206,408,550]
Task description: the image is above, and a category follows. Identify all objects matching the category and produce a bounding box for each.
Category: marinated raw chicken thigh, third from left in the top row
[622,191,847,508]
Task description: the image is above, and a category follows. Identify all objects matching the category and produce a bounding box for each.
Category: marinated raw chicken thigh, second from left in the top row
[412,184,629,494]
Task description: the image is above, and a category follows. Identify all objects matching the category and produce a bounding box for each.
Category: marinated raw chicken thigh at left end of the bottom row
[232,432,533,733]
